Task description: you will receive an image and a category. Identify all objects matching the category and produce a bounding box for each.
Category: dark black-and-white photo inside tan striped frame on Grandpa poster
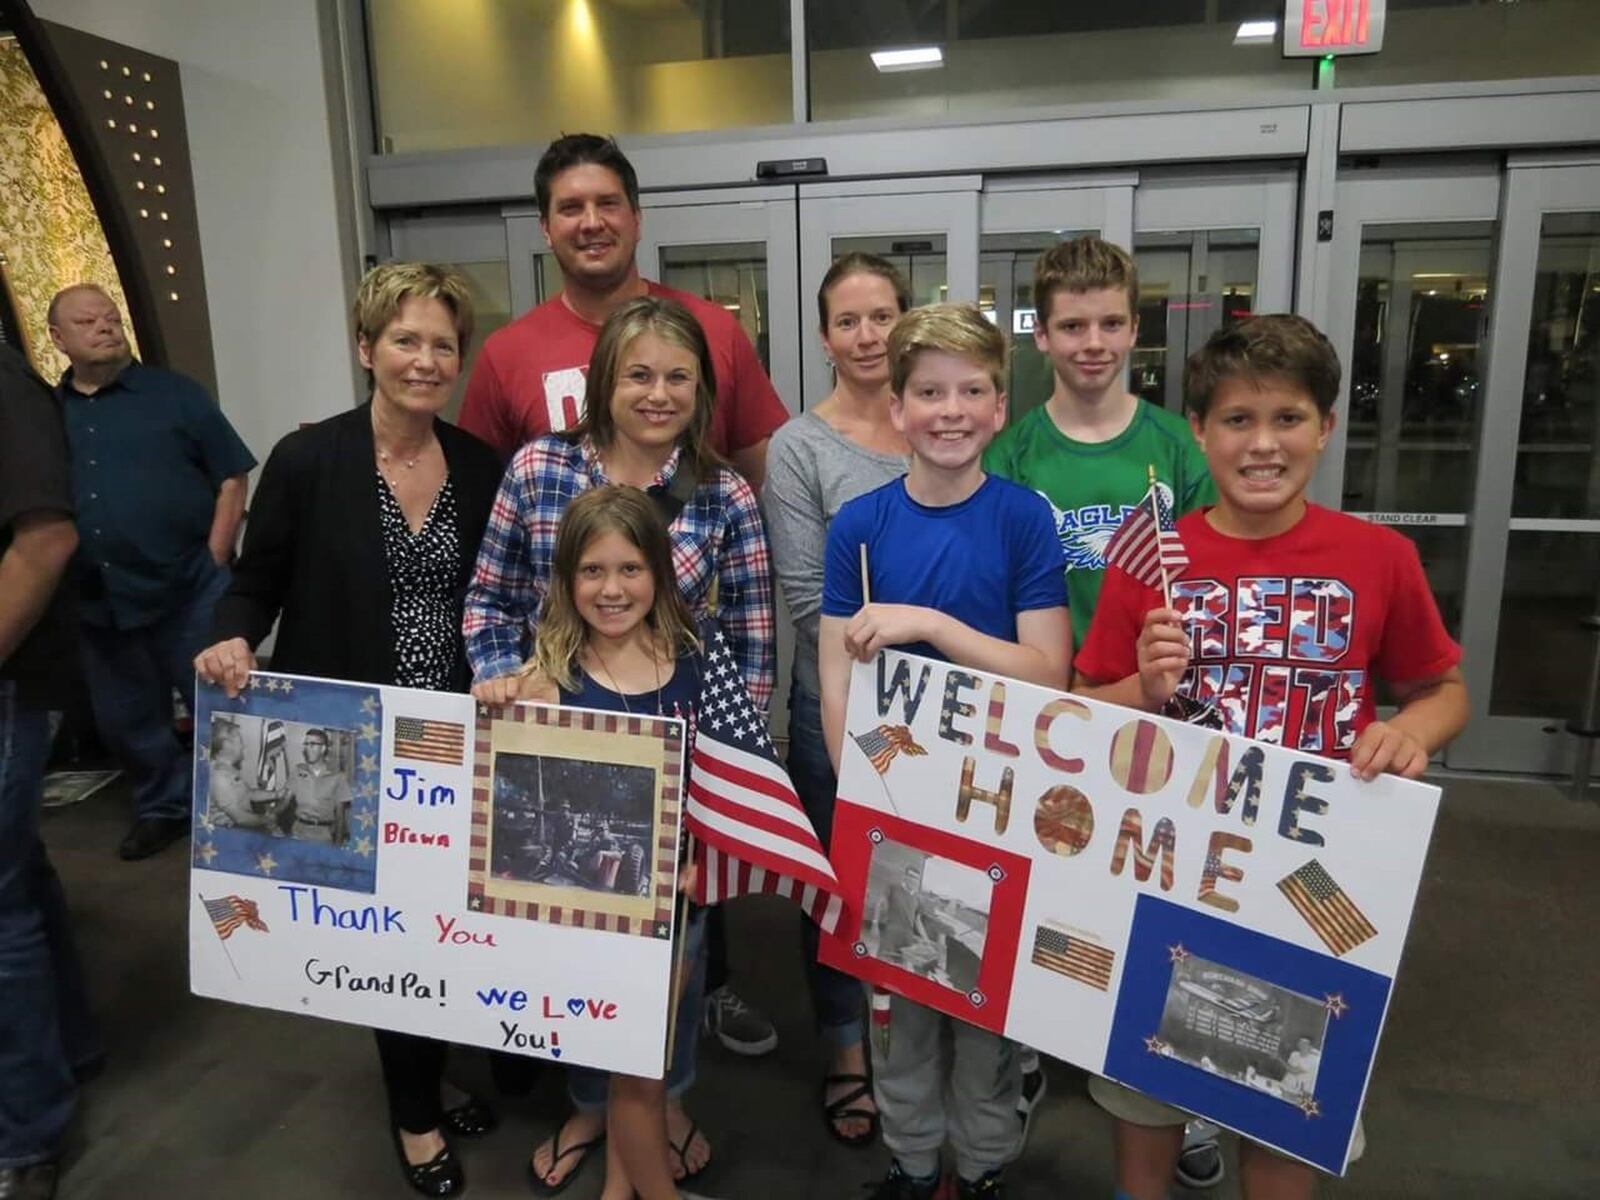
[490,752,656,896]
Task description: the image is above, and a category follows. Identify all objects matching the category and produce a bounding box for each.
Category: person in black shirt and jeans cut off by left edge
[0,344,98,1200]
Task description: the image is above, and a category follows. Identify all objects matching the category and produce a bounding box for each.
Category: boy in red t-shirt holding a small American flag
[1074,315,1467,1200]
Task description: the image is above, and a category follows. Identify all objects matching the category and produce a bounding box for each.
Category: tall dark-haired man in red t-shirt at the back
[461,133,789,491]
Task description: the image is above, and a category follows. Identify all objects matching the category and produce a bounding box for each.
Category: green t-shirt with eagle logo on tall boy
[984,400,1216,646]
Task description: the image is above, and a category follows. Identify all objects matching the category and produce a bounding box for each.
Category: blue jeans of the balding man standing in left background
[83,568,230,821]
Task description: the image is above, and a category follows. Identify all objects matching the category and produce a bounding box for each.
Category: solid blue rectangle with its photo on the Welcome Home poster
[1104,896,1392,1174]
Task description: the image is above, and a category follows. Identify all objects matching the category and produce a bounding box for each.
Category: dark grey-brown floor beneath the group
[37,781,1600,1200]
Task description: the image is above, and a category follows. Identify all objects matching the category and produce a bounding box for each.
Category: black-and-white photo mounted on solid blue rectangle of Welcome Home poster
[1157,954,1328,1106]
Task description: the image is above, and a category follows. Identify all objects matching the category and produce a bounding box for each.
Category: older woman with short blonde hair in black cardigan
[195,262,501,1195]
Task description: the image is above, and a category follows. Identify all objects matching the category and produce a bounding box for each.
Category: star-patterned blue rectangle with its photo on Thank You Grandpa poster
[194,674,384,894]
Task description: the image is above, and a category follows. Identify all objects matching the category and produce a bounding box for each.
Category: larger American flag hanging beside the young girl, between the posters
[683,629,845,933]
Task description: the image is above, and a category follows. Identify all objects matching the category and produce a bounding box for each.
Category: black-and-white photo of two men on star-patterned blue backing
[205,712,357,846]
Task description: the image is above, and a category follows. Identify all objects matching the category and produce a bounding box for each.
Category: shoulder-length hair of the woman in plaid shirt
[573,296,723,480]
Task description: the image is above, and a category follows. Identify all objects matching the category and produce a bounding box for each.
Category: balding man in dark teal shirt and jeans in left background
[50,283,256,859]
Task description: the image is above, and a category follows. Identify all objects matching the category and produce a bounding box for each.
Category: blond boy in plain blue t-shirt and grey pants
[818,304,1072,1200]
